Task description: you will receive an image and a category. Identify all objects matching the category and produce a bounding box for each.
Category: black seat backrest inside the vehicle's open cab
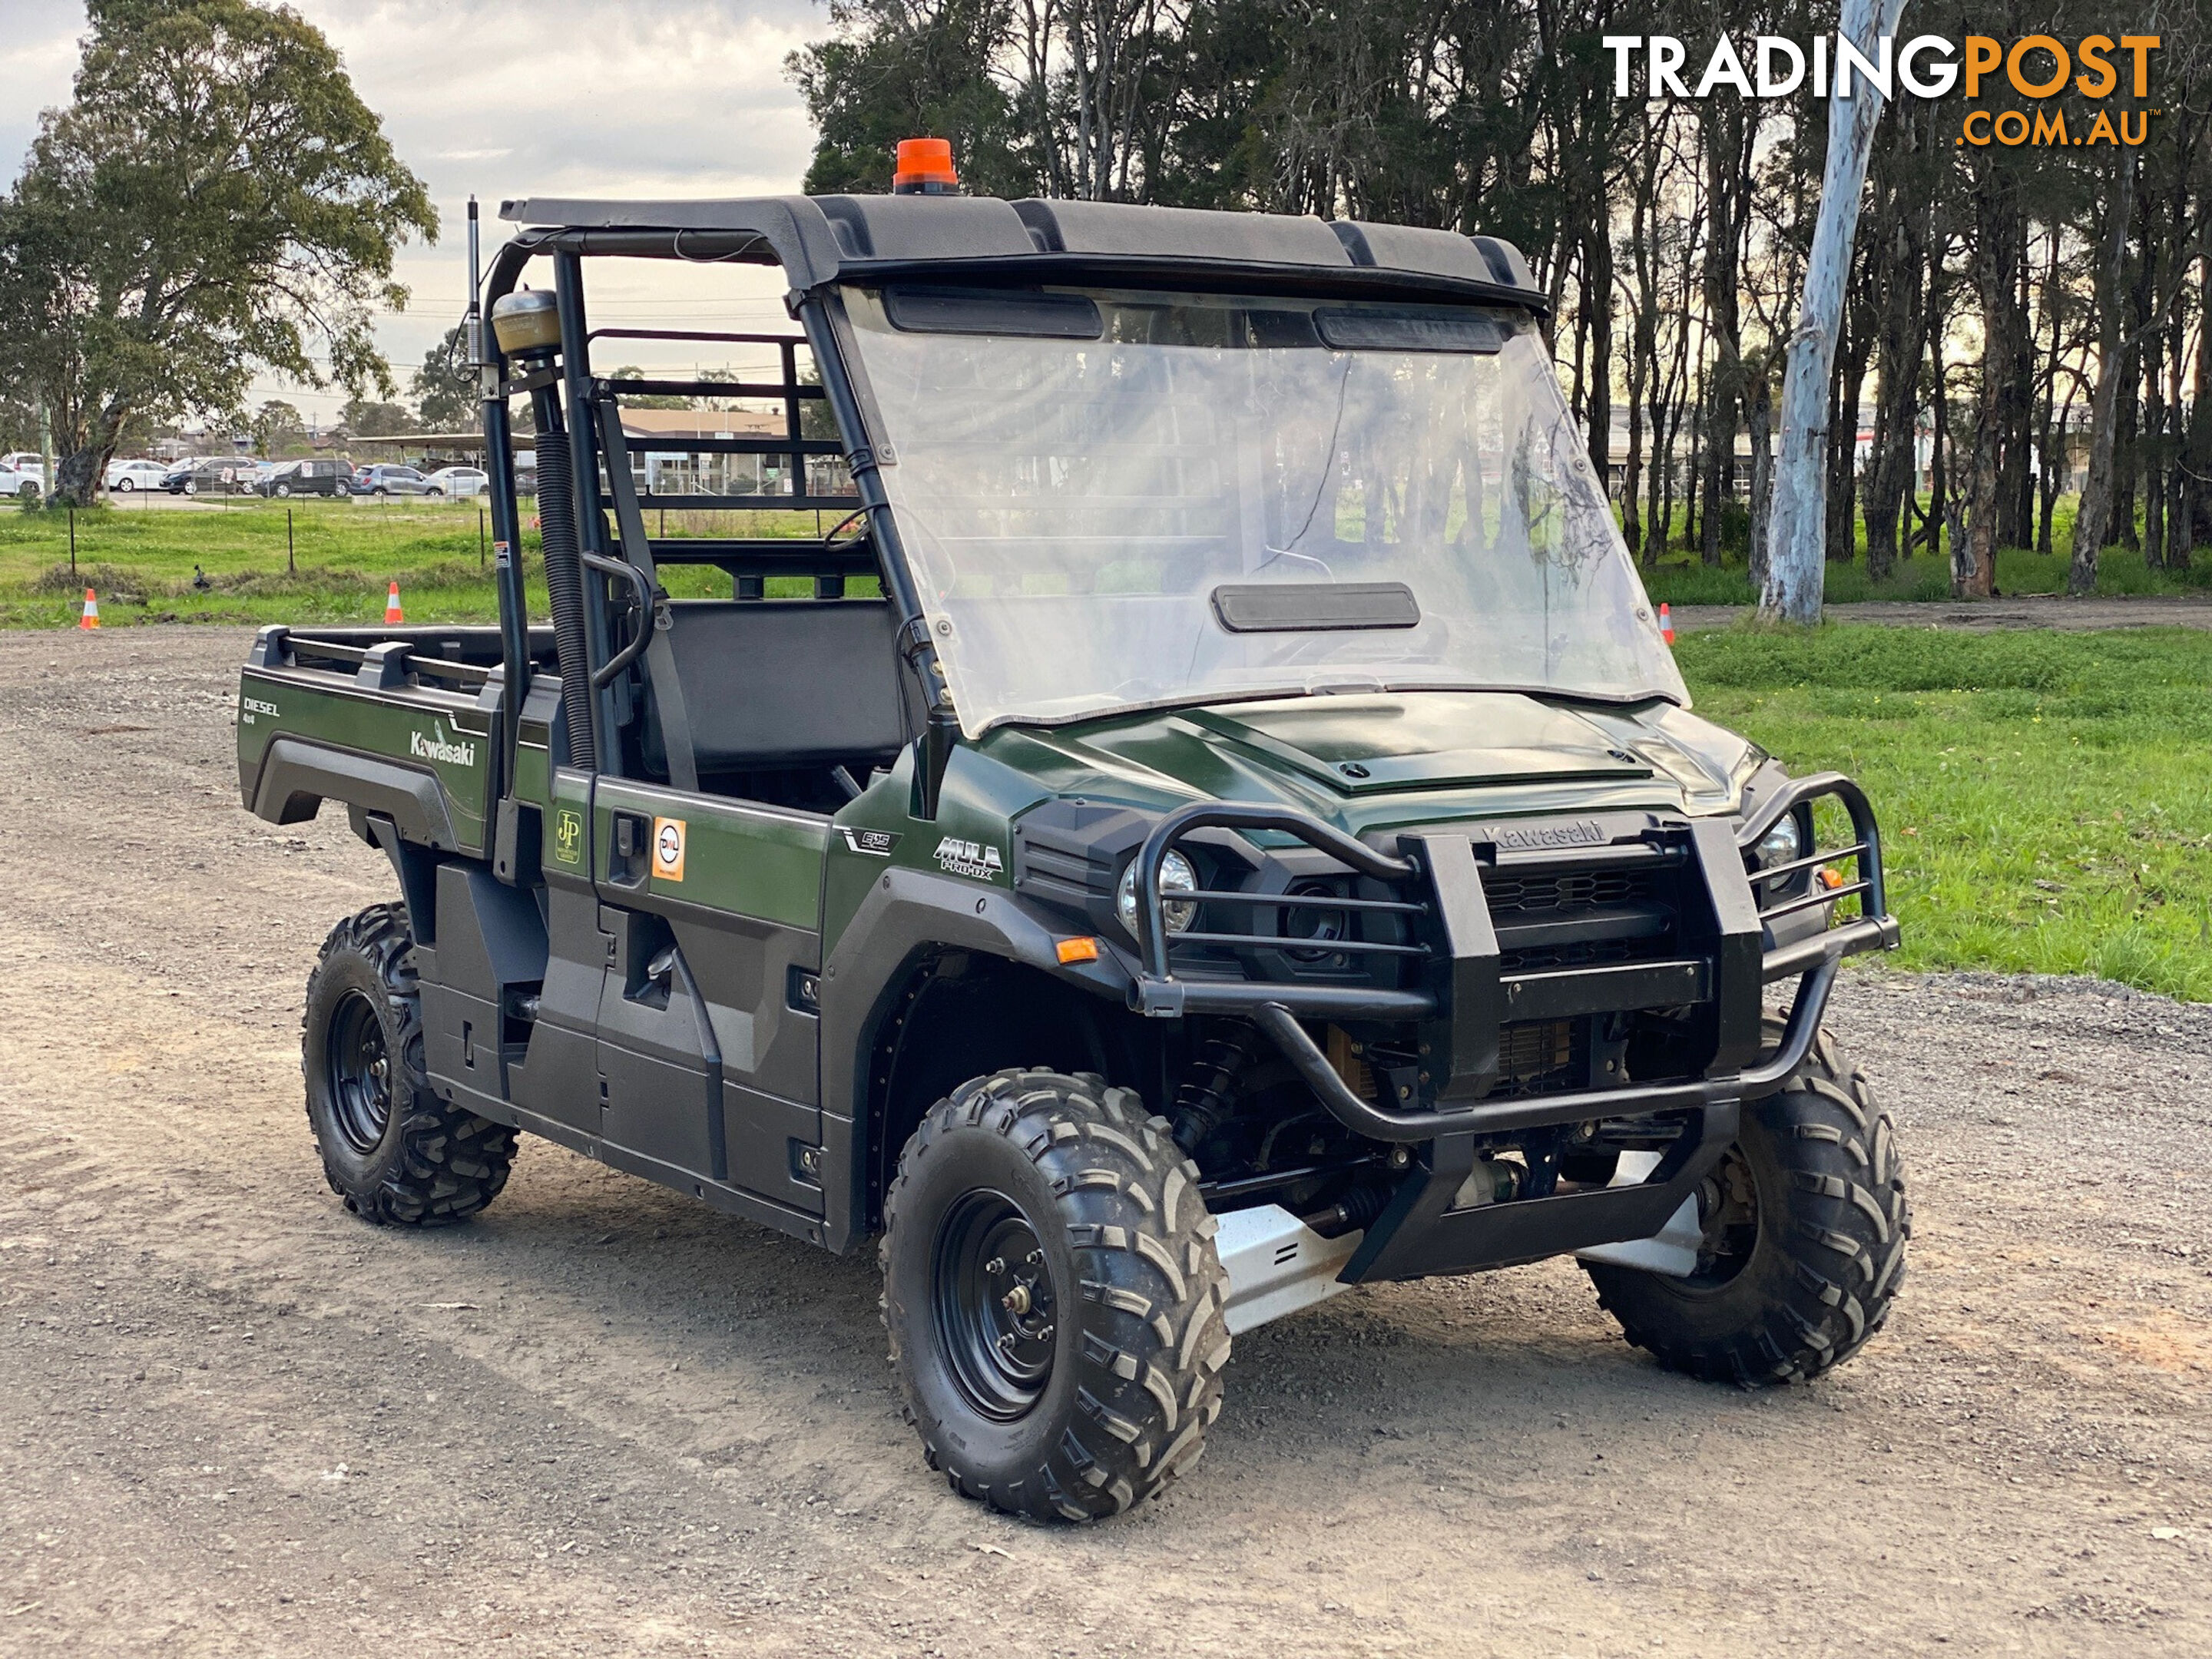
[668,599,920,774]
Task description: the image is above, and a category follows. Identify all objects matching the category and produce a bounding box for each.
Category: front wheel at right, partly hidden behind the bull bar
[1584,1015,1913,1387]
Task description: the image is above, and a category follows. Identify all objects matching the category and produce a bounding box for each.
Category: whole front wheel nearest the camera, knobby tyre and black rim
[882,1071,1230,1522]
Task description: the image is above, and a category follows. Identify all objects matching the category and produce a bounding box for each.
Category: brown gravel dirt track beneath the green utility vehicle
[0,628,2212,1654]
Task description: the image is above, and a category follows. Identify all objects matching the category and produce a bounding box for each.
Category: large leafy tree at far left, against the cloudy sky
[0,0,438,505]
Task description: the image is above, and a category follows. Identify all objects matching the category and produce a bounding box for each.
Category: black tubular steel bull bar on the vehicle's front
[1131,772,1898,1283]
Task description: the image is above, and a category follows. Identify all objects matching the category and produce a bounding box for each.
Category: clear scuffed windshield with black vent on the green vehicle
[847,290,1687,734]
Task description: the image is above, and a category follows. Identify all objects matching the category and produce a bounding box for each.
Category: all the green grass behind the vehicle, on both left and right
[0,502,2212,1000]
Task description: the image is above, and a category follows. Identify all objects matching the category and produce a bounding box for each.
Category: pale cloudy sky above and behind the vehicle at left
[0,0,825,420]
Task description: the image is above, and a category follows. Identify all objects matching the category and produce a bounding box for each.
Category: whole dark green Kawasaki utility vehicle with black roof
[239,166,1909,1520]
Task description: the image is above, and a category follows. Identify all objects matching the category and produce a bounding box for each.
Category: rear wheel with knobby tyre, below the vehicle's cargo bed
[301,905,515,1227]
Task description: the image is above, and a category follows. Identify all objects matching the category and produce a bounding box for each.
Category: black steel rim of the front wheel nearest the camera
[931,1188,1060,1422]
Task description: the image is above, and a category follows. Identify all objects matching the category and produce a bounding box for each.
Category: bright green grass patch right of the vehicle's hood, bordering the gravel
[1679,628,2212,1002]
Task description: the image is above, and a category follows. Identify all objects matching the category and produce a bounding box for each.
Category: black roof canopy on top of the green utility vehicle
[500,194,1548,312]
